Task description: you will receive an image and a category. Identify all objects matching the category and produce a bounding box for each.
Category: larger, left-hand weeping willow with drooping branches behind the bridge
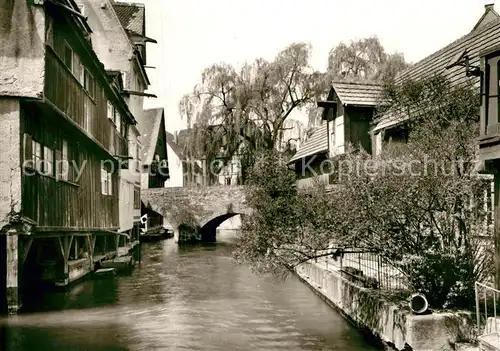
[179,43,324,182]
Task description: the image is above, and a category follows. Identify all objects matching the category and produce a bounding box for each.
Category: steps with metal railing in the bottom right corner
[475,282,500,351]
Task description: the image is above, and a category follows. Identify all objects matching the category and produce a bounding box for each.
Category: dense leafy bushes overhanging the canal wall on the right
[237,77,492,308]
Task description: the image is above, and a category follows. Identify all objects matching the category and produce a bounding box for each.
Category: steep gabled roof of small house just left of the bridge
[138,107,165,165]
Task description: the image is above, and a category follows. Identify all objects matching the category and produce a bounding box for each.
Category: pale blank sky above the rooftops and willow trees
[123,0,500,132]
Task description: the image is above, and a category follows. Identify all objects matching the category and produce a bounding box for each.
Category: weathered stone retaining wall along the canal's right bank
[296,263,473,351]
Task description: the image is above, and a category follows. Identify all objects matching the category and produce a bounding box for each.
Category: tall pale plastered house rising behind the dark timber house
[78,0,156,253]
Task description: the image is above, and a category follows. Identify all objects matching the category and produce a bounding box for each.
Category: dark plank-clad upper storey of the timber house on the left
[44,46,128,155]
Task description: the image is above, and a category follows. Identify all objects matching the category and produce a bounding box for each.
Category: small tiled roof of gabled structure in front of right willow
[332,82,383,106]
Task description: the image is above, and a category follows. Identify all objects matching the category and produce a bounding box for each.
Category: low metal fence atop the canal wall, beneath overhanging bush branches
[322,249,408,291]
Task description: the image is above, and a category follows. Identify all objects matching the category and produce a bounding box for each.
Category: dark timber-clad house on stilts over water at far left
[0,0,136,312]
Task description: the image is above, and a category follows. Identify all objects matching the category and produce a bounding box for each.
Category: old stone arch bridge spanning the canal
[141,185,252,243]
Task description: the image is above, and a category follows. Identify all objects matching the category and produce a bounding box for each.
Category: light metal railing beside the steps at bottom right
[474,282,500,334]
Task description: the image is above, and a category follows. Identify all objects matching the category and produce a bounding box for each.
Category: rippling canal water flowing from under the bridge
[0,240,375,351]
